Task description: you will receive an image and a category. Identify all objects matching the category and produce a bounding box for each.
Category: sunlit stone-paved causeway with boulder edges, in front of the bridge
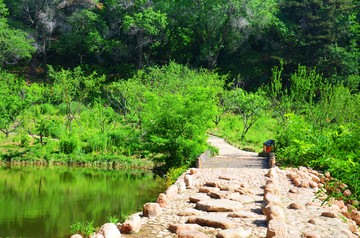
[73,138,360,238]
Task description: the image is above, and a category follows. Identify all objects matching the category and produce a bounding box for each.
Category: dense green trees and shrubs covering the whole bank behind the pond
[0,0,360,205]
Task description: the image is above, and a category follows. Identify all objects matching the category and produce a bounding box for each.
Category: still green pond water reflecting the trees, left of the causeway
[0,166,164,238]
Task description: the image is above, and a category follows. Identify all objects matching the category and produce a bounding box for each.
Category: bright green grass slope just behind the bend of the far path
[210,114,277,152]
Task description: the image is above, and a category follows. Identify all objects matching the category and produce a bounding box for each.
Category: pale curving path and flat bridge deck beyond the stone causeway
[202,136,269,168]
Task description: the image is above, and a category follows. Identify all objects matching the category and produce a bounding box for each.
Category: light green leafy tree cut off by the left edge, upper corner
[0,0,35,65]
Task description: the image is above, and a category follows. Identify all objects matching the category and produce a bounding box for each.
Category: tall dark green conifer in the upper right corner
[279,0,354,73]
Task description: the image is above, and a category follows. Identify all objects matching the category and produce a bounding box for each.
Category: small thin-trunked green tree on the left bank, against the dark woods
[49,66,105,132]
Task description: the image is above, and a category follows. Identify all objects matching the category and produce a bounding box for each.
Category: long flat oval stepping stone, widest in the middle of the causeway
[196,199,243,212]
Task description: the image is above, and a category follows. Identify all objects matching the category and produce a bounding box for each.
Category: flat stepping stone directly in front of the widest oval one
[188,215,236,229]
